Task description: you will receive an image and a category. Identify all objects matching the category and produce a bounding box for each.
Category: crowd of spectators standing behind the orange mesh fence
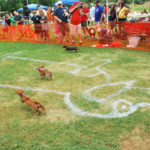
[1,0,133,44]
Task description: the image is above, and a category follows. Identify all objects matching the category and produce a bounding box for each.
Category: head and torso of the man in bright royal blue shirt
[95,0,104,23]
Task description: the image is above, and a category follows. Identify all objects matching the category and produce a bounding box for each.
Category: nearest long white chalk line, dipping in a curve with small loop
[0,84,150,119]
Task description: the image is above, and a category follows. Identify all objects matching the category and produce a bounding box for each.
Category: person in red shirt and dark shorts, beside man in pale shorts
[80,2,89,37]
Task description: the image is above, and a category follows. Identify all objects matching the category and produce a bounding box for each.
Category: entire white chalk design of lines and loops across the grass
[0,52,150,118]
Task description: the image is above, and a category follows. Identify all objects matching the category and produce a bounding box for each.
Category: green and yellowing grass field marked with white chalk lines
[0,43,150,150]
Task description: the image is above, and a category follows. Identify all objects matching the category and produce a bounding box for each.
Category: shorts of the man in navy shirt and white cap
[58,22,70,36]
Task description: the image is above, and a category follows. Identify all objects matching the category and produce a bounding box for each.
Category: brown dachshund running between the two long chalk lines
[36,66,52,79]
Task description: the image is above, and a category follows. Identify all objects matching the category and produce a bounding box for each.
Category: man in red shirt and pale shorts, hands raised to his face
[69,1,82,44]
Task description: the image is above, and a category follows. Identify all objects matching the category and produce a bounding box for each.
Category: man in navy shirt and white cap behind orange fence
[54,1,70,42]
